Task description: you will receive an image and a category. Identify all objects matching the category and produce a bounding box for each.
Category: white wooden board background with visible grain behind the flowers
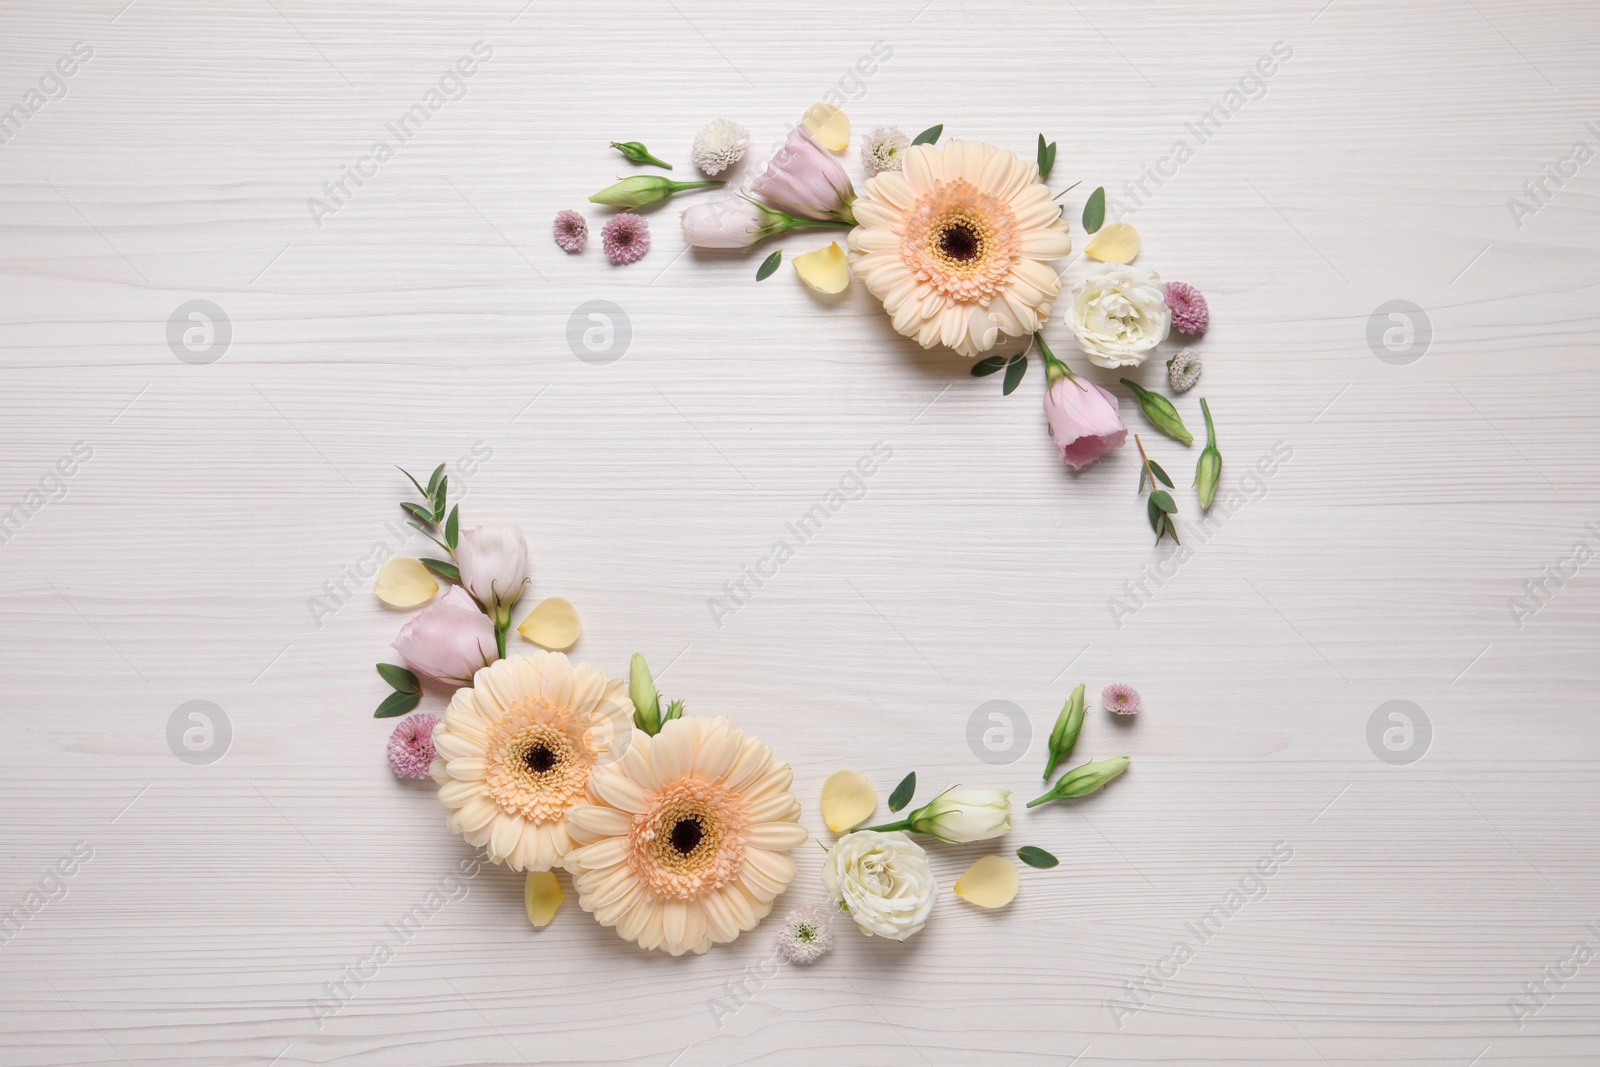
[0,0,1600,1067]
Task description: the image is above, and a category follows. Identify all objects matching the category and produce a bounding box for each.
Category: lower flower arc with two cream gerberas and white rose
[374,464,1139,963]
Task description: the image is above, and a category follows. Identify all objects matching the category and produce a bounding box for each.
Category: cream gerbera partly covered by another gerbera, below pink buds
[430,651,634,870]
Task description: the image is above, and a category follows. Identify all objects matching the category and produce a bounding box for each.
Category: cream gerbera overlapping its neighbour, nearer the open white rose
[566,717,806,955]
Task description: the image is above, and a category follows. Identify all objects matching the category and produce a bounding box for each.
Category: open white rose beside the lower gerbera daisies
[822,830,938,941]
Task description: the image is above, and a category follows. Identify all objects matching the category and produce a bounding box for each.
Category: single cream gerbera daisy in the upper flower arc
[850,141,1072,357]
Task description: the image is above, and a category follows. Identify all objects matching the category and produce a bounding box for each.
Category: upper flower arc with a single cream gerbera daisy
[555,104,1222,542]
